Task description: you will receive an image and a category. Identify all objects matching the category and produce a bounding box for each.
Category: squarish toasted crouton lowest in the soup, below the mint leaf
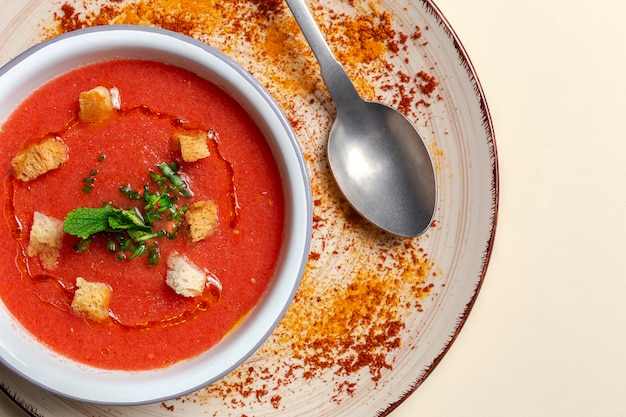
[72,277,112,321]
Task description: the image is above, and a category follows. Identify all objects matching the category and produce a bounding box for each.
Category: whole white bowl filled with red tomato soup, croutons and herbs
[0,26,312,404]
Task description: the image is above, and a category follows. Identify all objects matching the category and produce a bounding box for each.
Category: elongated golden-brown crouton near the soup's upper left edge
[11,138,69,182]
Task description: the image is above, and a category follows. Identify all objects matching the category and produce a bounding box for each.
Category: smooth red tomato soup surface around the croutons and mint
[0,60,284,370]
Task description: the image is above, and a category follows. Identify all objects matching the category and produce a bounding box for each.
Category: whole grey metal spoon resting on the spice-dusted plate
[286,0,437,237]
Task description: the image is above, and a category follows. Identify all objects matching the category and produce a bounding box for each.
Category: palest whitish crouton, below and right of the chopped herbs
[165,253,208,297]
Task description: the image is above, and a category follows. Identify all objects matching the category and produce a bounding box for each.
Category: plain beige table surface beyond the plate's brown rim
[0,0,626,417]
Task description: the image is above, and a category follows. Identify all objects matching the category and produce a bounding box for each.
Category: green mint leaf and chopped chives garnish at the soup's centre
[63,162,193,266]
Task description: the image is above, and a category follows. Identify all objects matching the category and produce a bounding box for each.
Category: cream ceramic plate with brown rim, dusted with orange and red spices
[0,0,498,417]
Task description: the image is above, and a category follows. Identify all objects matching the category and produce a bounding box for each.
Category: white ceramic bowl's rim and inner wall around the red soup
[0,26,312,404]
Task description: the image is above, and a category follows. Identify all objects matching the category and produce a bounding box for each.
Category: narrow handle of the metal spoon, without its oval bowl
[285,0,360,110]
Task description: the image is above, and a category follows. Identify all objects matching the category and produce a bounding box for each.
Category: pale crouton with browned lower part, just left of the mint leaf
[27,211,63,271]
